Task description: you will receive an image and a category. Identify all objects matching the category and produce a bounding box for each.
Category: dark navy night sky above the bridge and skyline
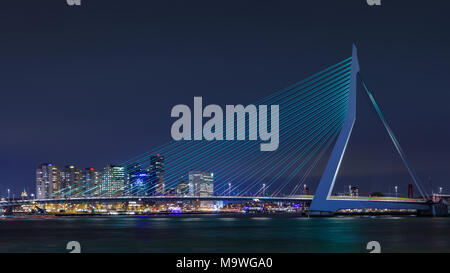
[0,0,450,195]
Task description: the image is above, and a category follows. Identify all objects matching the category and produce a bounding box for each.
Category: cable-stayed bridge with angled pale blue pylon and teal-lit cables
[0,46,442,214]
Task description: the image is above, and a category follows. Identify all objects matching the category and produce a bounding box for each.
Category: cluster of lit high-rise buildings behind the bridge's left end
[27,154,219,199]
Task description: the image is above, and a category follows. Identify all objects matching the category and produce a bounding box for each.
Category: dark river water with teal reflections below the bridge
[0,215,450,252]
